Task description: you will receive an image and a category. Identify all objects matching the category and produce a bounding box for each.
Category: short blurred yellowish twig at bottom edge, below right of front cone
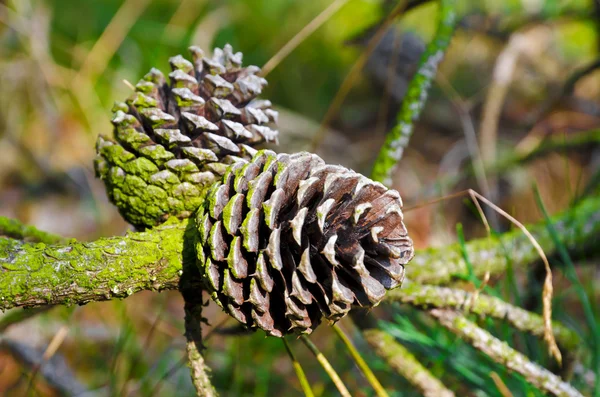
[363,328,454,397]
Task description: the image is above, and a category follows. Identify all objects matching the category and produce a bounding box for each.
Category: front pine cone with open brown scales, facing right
[195,151,413,337]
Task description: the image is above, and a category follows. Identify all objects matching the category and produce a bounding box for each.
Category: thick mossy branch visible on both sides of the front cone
[0,193,600,310]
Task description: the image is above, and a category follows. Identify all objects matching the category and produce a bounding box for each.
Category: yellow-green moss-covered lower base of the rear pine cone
[95,130,215,228]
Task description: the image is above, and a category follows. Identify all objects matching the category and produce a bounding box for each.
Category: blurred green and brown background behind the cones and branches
[0,0,600,396]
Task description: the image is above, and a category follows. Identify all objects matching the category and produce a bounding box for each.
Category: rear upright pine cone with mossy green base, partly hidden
[95,45,277,228]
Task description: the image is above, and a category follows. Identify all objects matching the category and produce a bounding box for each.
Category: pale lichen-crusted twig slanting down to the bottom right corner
[429,309,583,397]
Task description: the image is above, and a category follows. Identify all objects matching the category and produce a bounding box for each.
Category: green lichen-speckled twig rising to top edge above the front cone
[371,0,456,186]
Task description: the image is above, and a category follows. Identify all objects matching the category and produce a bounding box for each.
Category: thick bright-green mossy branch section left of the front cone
[0,220,193,310]
